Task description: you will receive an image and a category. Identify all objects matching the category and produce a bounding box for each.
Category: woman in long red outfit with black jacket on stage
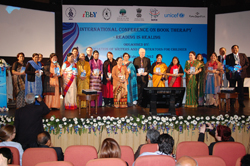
[102,52,117,107]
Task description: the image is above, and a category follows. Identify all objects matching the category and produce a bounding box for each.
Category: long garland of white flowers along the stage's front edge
[0,114,250,136]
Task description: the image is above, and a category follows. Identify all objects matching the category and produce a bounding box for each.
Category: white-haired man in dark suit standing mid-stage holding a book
[133,48,151,106]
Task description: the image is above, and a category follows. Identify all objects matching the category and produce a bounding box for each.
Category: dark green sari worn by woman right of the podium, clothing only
[185,60,204,108]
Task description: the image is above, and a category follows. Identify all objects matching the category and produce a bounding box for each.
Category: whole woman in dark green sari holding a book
[184,51,204,108]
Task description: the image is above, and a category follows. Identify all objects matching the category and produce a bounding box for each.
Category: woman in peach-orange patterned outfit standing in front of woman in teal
[112,57,129,108]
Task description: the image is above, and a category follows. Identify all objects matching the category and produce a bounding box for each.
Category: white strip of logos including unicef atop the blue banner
[63,5,207,24]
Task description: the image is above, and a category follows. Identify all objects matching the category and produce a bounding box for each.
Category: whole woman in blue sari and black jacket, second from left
[25,53,43,96]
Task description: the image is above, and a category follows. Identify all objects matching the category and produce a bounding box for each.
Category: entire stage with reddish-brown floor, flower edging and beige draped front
[0,98,250,153]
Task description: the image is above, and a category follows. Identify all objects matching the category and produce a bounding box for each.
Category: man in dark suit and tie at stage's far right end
[226,45,249,107]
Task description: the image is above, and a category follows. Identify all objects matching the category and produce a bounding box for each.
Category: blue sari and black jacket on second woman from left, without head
[25,60,43,96]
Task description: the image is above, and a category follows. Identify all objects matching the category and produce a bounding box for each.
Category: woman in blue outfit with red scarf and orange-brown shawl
[205,52,224,107]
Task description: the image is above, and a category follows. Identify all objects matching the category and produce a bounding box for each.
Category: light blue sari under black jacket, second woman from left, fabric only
[25,60,43,96]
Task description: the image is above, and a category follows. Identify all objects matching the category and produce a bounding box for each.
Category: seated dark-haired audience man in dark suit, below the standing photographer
[37,131,64,161]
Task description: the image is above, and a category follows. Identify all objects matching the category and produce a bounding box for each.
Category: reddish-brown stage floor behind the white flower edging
[0,98,250,118]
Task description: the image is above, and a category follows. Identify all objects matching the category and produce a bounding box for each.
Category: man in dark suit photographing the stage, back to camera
[14,93,50,150]
